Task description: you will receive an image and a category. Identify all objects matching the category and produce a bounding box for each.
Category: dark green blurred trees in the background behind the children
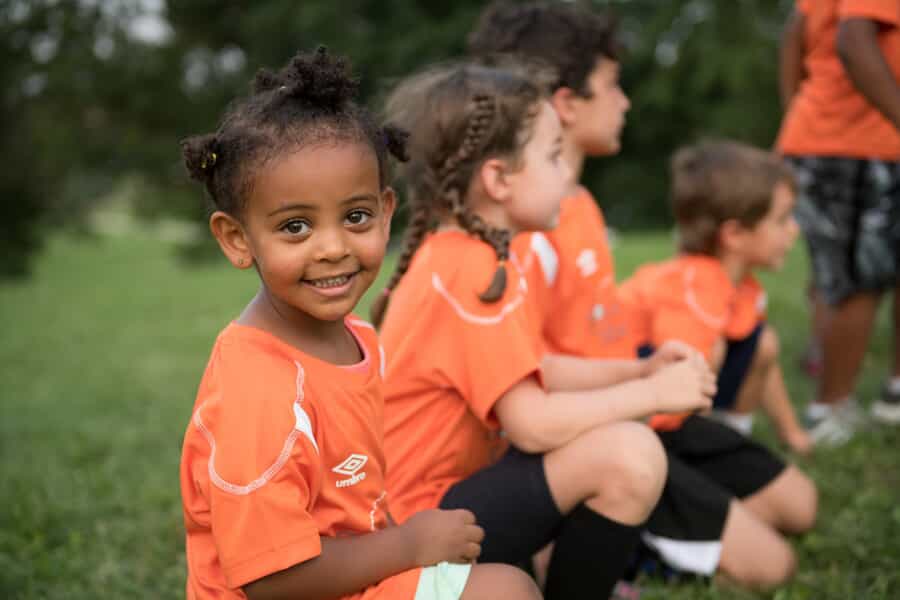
[0,0,791,276]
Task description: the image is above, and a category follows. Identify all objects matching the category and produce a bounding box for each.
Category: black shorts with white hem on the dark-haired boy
[642,416,786,575]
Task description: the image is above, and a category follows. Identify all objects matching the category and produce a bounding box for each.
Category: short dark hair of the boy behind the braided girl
[468,0,621,98]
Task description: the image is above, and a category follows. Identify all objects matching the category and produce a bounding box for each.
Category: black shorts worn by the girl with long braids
[440,447,564,564]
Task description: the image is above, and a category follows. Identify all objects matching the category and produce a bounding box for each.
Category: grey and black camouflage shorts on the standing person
[788,156,900,305]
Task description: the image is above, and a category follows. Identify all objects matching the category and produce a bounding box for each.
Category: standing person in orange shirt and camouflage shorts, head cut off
[777,0,900,444]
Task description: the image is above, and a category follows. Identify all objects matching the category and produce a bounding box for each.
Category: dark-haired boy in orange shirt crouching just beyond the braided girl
[469,2,816,587]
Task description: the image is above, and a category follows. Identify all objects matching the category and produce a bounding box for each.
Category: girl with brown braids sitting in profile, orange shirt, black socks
[374,65,714,600]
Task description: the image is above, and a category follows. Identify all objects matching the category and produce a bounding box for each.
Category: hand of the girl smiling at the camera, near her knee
[402,509,484,567]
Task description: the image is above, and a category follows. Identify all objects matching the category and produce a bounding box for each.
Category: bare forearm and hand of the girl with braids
[494,358,716,453]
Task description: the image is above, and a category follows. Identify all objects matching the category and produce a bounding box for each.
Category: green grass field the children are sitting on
[0,234,900,600]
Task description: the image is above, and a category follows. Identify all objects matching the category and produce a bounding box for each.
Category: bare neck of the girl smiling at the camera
[238,286,363,365]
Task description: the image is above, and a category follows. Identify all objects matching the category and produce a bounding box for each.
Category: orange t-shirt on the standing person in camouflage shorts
[777,0,900,161]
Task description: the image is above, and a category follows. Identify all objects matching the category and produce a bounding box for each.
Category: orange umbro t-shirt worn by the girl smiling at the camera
[181,317,421,600]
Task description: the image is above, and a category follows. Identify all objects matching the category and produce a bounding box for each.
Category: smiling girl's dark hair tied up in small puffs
[181,46,408,218]
